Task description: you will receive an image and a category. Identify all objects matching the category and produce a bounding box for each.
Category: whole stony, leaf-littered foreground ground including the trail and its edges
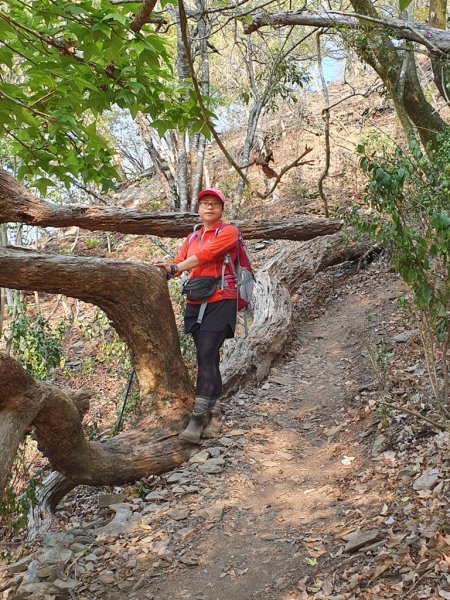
[0,255,450,600]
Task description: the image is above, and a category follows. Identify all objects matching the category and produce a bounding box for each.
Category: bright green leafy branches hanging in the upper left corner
[0,0,207,195]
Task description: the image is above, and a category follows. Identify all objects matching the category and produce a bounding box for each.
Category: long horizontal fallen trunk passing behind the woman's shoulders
[0,169,342,241]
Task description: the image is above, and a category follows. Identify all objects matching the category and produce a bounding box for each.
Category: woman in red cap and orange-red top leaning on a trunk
[153,188,238,443]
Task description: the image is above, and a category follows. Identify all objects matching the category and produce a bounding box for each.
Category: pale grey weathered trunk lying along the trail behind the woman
[222,234,372,393]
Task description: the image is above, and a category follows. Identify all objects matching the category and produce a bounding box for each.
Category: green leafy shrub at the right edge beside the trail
[348,133,450,401]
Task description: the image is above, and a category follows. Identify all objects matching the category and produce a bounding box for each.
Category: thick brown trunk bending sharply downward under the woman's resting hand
[0,248,191,412]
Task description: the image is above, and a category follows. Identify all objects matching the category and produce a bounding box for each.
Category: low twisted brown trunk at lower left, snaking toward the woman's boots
[0,354,192,507]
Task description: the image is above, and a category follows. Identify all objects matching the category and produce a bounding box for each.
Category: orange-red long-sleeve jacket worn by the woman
[173,221,239,304]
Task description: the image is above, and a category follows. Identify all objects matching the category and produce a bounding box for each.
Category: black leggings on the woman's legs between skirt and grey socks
[192,329,228,398]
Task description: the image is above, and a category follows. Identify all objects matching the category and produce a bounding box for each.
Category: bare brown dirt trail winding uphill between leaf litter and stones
[106,269,400,600]
